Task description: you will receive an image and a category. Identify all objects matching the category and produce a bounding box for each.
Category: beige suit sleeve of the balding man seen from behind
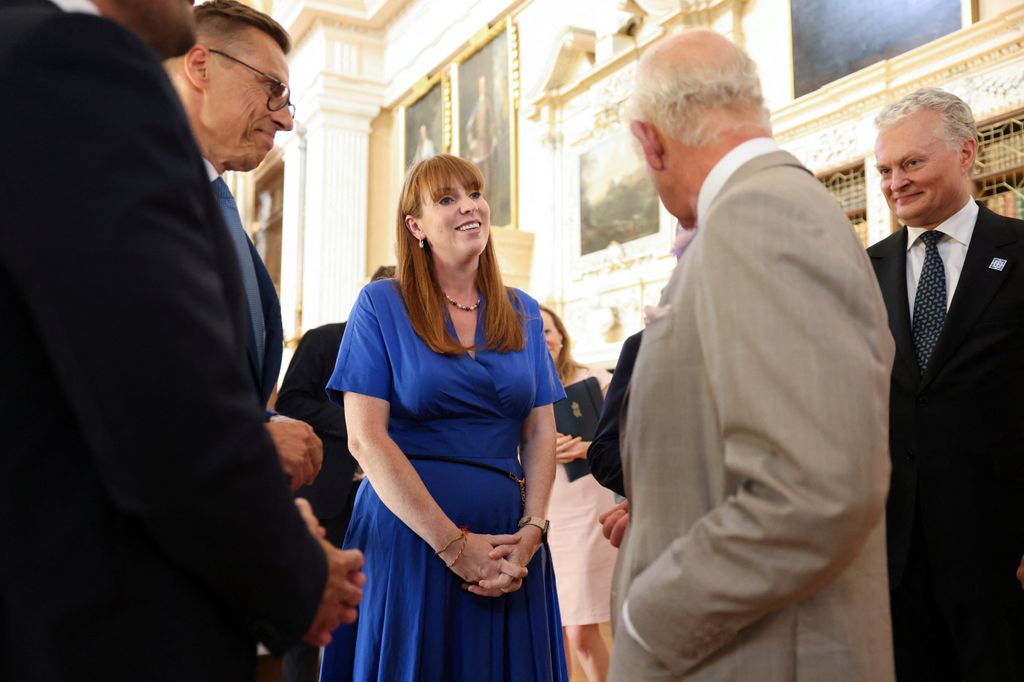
[628,179,893,675]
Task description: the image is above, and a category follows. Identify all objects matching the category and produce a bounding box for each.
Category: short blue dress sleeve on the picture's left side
[327,282,392,404]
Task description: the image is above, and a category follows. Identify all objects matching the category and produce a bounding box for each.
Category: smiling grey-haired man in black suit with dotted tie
[868,88,1024,681]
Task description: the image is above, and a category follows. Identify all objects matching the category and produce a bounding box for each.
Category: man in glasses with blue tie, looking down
[167,0,324,489]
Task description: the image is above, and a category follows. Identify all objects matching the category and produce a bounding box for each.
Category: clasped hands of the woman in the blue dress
[441,525,541,597]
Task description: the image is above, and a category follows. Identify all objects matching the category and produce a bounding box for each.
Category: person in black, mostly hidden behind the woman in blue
[276,265,394,682]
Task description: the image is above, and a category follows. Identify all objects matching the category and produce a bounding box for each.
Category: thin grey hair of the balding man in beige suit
[630,32,771,147]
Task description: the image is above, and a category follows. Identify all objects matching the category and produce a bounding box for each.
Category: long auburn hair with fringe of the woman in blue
[396,154,526,355]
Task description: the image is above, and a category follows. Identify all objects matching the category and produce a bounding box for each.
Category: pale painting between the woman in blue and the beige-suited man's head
[580,131,658,255]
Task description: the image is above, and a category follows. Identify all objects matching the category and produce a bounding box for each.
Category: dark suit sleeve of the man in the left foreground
[0,14,326,651]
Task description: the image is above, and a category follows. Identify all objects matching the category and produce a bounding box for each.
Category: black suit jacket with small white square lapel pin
[868,201,1024,606]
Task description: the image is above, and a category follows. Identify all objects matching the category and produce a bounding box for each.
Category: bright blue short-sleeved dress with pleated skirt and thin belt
[321,281,567,682]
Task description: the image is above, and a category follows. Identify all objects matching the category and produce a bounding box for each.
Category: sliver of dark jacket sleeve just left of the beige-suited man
[587,332,643,496]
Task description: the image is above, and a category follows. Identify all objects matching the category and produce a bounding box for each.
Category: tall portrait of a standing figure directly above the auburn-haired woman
[458,31,513,226]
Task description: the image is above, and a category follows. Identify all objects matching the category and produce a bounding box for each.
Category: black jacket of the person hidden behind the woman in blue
[276,323,355,519]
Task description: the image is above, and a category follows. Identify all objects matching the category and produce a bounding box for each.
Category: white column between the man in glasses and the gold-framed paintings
[281,13,384,338]
